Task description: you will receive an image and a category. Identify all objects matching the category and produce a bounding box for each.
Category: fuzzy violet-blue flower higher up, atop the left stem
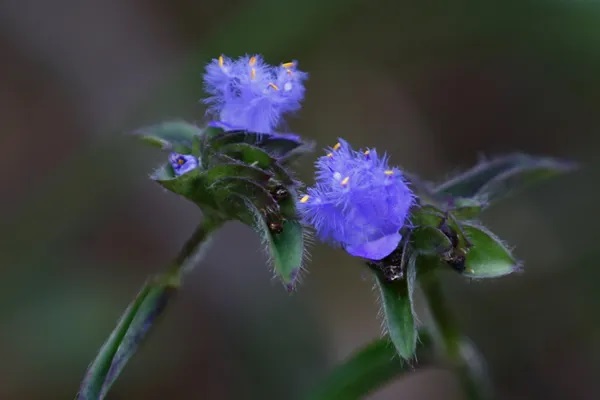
[204,55,308,133]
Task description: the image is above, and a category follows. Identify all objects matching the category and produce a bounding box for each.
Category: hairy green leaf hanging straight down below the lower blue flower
[375,254,417,360]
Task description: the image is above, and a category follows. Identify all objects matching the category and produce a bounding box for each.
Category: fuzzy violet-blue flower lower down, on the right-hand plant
[298,139,415,260]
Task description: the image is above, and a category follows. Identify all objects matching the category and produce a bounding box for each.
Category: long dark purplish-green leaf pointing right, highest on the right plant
[434,153,576,201]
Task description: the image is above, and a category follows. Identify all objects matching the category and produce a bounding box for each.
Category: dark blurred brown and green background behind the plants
[0,0,600,400]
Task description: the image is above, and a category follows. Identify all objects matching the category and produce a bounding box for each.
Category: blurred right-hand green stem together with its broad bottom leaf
[305,271,493,400]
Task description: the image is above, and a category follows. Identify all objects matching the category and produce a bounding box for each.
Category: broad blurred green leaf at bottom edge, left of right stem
[306,331,434,400]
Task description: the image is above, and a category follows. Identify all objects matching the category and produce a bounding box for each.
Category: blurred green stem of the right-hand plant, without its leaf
[420,271,491,400]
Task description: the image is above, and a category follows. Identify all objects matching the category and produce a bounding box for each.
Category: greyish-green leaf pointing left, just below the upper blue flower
[136,121,203,154]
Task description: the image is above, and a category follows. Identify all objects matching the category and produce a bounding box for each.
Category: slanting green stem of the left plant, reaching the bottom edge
[76,217,222,400]
